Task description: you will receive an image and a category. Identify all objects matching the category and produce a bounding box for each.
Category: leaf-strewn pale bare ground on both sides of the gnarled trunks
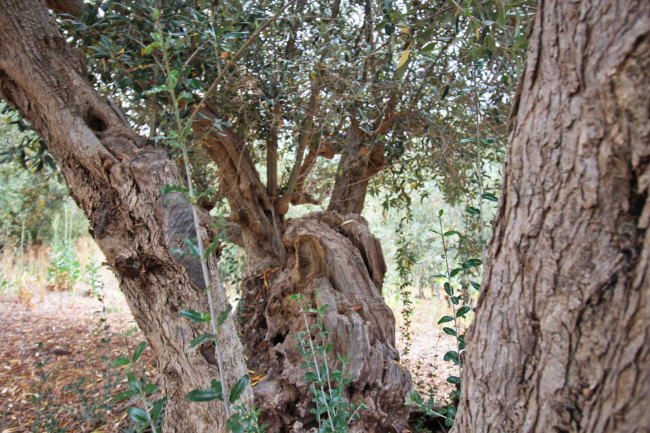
[0,258,458,433]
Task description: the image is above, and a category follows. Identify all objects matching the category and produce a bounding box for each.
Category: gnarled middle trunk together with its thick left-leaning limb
[195,113,411,432]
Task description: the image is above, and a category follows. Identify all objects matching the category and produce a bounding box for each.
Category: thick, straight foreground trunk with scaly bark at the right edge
[453,0,650,433]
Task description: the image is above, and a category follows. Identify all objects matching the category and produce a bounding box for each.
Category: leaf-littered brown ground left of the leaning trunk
[0,280,155,433]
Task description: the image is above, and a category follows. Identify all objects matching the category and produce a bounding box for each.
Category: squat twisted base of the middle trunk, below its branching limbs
[240,212,411,432]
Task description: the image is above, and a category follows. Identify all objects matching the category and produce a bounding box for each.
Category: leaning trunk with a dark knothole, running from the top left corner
[0,0,252,433]
